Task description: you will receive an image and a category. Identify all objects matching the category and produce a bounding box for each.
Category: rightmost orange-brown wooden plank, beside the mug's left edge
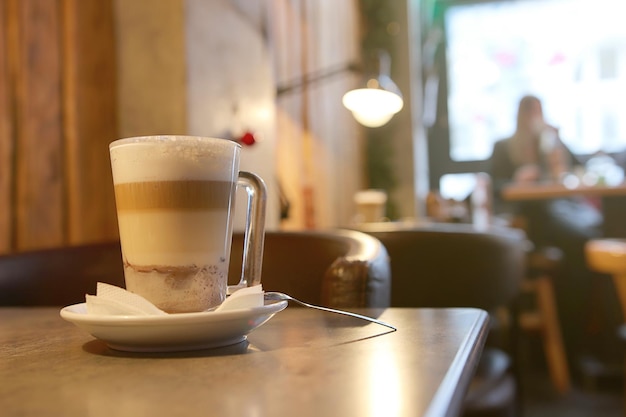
[63,0,118,243]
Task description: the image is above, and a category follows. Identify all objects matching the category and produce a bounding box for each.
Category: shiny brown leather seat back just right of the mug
[229,230,391,308]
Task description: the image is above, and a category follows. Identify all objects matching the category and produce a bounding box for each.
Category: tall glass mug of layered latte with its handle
[109,135,266,313]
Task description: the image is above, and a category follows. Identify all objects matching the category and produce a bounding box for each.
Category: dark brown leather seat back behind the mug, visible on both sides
[0,231,391,308]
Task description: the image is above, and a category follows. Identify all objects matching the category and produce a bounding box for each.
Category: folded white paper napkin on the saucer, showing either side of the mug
[85,282,264,316]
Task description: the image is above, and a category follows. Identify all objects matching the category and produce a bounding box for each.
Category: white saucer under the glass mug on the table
[61,301,287,352]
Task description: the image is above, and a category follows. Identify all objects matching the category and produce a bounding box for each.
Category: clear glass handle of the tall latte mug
[236,171,267,288]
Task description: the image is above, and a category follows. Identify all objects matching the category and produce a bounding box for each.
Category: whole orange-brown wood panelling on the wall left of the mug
[0,0,117,253]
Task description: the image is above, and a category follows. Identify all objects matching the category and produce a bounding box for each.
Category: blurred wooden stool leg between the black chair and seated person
[519,247,571,393]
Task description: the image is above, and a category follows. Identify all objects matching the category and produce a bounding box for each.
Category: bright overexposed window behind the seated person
[444,0,626,161]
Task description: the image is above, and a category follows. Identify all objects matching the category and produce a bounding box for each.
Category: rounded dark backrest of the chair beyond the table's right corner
[359,223,526,311]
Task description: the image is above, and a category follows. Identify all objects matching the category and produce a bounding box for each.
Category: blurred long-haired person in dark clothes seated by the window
[490,96,602,368]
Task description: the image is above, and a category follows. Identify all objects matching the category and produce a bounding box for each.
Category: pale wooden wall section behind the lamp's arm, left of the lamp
[269,0,363,229]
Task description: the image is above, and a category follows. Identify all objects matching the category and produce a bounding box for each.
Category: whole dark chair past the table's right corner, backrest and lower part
[358,223,526,416]
